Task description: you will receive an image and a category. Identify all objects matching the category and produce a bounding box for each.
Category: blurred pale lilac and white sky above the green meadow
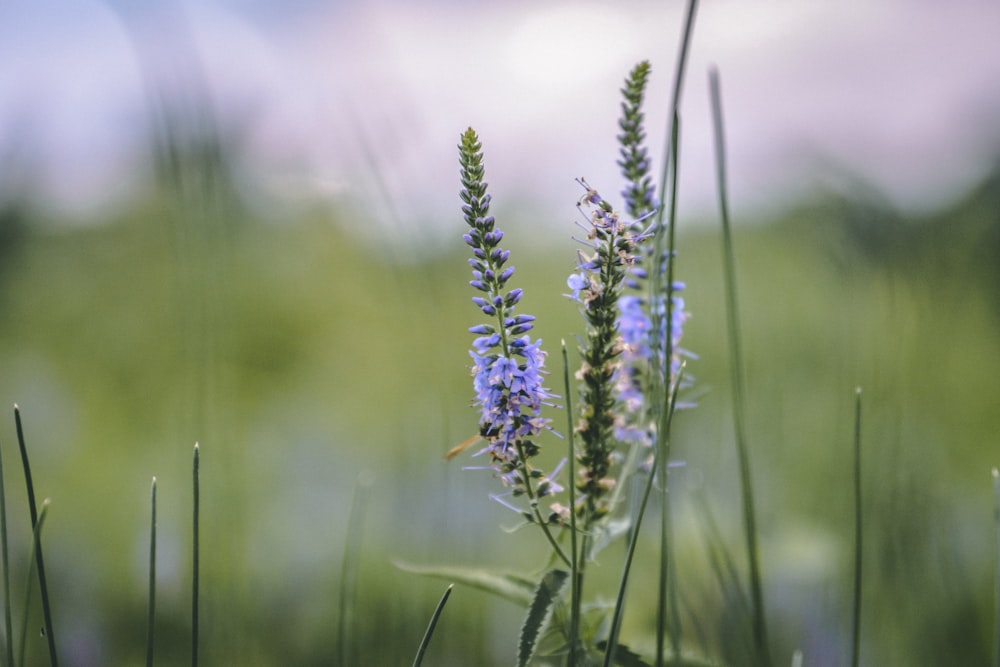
[0,0,1000,235]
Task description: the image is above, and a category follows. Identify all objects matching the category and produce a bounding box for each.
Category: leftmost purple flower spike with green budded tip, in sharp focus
[459,128,560,496]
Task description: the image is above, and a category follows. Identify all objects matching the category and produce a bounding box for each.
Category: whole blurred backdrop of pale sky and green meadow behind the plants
[0,0,1000,667]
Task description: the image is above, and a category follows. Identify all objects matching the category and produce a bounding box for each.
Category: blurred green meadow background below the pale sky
[0,163,1000,665]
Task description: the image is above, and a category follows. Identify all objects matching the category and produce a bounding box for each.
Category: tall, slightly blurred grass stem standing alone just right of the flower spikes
[708,67,773,666]
